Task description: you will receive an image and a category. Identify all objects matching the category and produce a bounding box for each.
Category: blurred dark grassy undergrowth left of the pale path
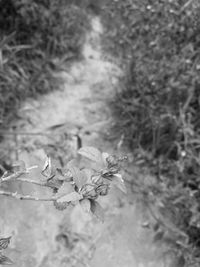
[0,0,89,126]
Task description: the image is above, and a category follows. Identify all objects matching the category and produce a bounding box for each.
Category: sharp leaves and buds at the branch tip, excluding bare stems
[51,147,126,220]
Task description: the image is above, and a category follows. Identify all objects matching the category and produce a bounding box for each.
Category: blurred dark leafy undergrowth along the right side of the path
[104,0,200,266]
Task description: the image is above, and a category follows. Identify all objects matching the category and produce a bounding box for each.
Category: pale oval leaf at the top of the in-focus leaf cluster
[78,146,102,163]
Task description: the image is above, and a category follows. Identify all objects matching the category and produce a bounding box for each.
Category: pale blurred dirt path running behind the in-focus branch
[0,17,168,267]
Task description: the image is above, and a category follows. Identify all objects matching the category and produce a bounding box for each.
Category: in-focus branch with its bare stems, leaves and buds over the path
[0,147,126,221]
